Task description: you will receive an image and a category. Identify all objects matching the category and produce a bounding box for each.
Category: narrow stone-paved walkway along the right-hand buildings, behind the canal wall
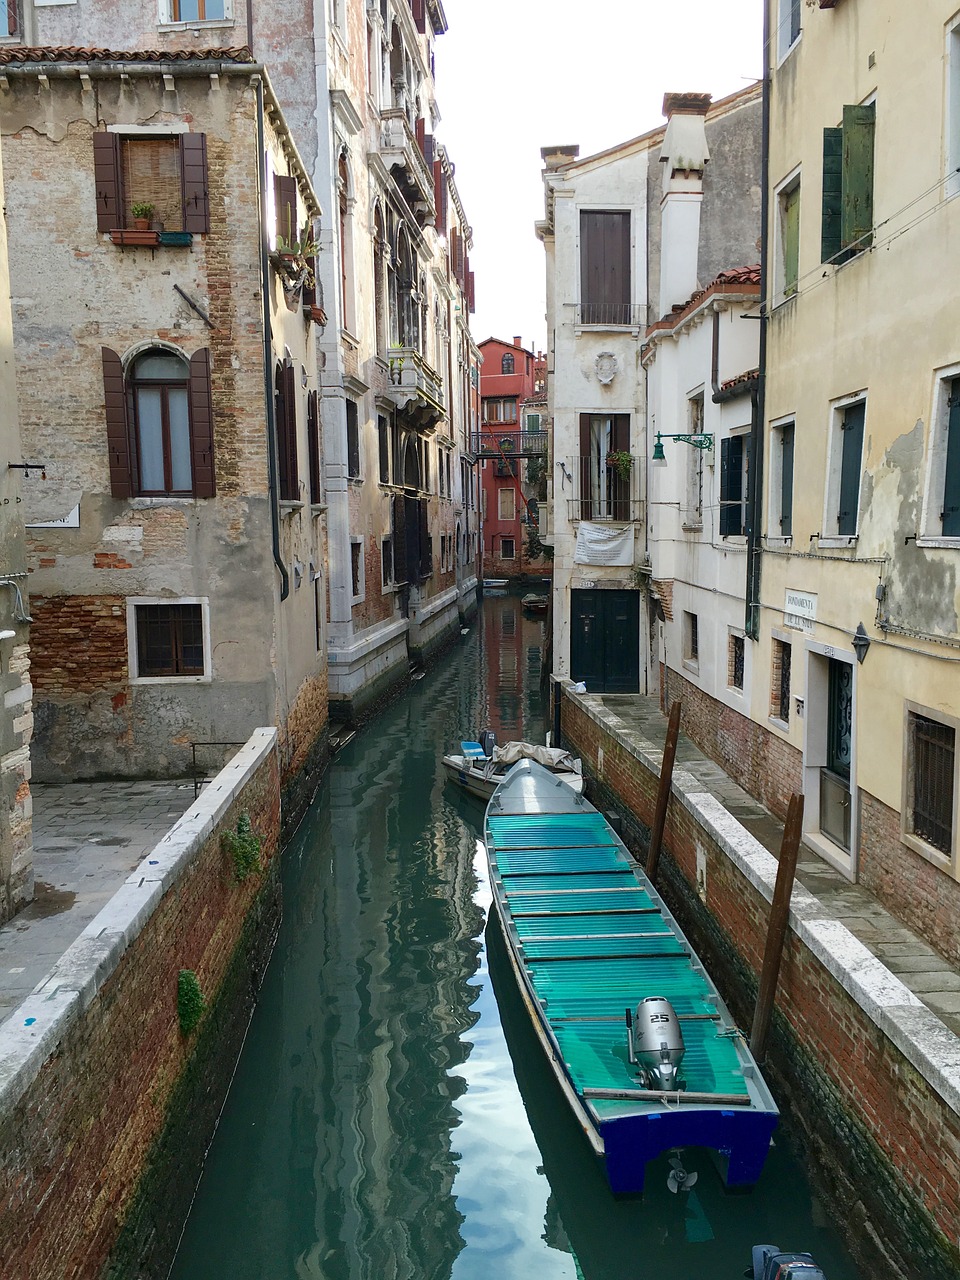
[598,694,960,1036]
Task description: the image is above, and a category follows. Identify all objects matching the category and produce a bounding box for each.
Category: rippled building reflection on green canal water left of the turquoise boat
[284,669,483,1280]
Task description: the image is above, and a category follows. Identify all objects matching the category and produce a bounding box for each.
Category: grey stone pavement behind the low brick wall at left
[0,781,193,1021]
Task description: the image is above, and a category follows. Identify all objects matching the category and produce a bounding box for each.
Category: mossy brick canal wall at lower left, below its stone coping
[0,732,280,1280]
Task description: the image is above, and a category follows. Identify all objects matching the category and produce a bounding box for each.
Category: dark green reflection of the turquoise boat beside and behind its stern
[486,916,855,1280]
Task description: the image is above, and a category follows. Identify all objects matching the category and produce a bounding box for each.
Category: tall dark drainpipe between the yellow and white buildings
[744,0,771,640]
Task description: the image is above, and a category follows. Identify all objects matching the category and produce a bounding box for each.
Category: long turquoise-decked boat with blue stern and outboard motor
[484,760,780,1193]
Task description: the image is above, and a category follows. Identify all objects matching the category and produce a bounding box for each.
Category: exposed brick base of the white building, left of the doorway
[660,663,803,818]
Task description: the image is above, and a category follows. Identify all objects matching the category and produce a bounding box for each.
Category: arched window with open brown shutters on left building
[101,346,216,498]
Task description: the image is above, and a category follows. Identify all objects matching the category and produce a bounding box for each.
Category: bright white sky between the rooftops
[435,0,763,349]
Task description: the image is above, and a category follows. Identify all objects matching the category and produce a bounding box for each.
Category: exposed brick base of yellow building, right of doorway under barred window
[859,790,960,964]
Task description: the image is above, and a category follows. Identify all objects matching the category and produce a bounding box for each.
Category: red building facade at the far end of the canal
[479,338,550,580]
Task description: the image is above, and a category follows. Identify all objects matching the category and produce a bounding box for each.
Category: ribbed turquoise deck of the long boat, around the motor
[488,812,751,1120]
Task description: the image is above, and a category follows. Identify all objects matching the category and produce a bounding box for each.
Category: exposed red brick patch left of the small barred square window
[31,595,127,698]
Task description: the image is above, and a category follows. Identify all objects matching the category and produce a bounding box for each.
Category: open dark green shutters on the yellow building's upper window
[820,102,877,262]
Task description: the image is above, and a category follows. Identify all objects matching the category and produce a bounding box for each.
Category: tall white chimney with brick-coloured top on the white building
[659,93,710,316]
